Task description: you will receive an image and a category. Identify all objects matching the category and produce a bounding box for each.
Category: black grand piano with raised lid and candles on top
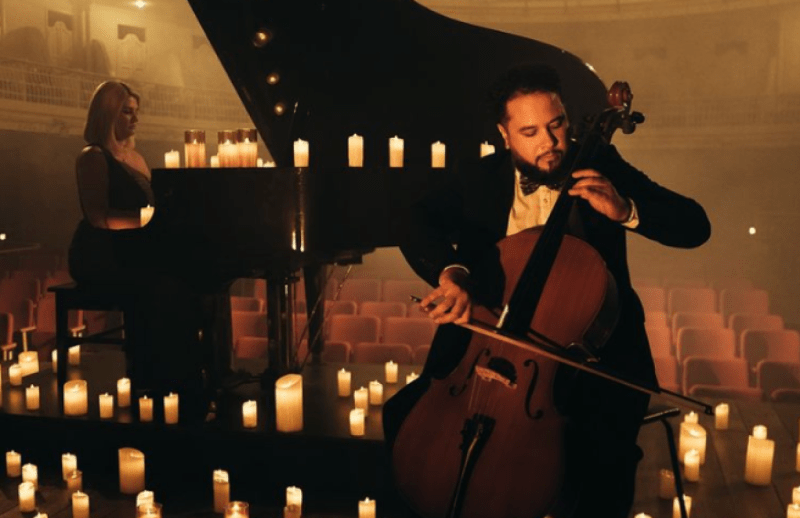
[151,0,606,375]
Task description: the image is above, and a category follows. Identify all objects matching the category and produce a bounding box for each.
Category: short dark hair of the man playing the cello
[489,63,561,124]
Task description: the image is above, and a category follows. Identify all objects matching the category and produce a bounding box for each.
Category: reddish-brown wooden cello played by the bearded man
[392,83,712,518]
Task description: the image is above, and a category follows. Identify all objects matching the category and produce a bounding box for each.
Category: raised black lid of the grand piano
[184,0,606,171]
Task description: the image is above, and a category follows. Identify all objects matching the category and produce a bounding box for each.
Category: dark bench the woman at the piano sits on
[47,282,135,414]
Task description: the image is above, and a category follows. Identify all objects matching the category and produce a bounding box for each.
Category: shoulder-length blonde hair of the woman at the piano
[83,81,139,148]
